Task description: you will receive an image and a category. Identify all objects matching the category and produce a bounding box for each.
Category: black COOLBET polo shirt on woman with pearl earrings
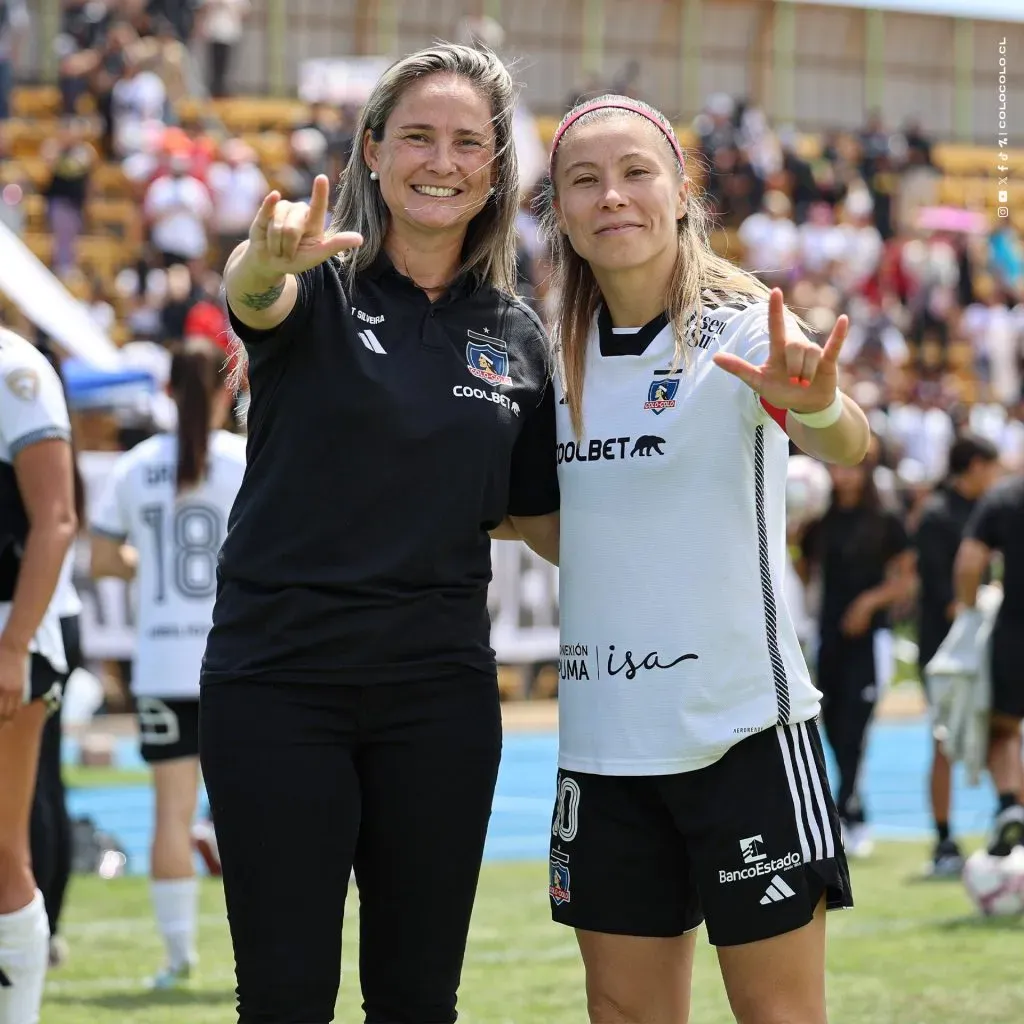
[203,256,558,683]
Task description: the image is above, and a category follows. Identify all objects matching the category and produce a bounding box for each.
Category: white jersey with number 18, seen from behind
[91,431,246,698]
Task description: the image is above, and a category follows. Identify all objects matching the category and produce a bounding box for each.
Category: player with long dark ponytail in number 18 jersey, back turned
[91,341,245,988]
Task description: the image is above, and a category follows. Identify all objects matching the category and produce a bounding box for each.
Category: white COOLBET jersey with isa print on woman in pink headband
[557,303,820,775]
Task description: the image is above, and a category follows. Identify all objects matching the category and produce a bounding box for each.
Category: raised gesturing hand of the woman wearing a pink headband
[715,288,850,413]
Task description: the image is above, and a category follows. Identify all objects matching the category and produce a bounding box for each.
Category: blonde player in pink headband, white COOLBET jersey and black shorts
[528,96,868,1024]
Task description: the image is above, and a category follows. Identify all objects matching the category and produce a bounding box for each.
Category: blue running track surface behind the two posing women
[66,721,994,872]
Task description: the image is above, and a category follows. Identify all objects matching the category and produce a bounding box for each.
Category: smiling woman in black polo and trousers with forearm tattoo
[195,45,558,1024]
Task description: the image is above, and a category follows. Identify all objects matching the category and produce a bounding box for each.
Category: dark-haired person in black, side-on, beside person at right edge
[914,434,999,877]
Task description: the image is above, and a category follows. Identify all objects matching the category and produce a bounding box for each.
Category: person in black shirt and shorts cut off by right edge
[954,476,1024,857]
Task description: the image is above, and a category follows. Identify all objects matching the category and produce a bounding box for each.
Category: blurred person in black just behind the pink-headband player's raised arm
[802,450,914,857]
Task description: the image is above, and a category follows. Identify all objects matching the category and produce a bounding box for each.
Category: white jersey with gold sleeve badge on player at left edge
[0,329,71,672]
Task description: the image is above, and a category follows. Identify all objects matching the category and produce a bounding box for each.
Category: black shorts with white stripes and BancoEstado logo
[549,721,853,946]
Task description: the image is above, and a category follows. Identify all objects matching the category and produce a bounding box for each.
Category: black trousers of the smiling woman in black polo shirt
[200,671,501,1024]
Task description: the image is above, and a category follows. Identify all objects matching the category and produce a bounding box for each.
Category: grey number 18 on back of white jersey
[142,505,224,604]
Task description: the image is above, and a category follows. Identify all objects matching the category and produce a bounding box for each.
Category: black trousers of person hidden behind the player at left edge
[30,615,82,935]
